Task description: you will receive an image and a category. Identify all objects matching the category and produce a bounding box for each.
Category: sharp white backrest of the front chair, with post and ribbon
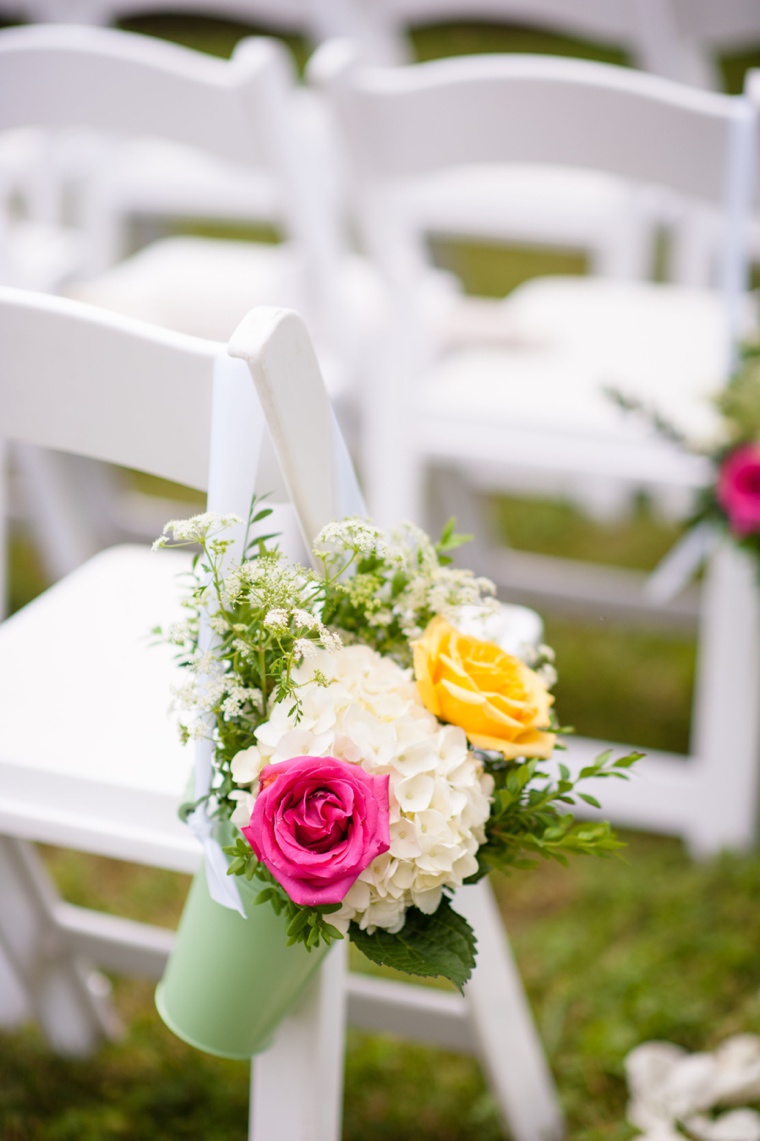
[0,289,363,597]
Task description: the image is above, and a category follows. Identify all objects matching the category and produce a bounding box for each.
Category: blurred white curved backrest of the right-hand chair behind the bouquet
[309,42,757,308]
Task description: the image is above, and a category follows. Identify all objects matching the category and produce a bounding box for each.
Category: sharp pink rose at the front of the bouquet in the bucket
[242,756,390,907]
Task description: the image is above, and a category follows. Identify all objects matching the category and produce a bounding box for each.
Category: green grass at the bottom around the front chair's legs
[0,835,760,1141]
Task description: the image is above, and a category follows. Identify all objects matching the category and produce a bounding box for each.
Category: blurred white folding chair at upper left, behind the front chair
[0,26,346,353]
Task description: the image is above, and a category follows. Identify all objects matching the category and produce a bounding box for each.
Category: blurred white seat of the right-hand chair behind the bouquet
[420,278,727,486]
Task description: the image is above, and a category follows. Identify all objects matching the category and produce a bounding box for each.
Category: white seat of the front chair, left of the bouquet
[0,545,200,871]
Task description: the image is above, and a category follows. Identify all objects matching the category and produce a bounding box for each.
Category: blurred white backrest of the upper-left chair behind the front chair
[0,25,338,304]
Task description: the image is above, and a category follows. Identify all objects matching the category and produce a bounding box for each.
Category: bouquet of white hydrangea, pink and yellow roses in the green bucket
[155,501,638,988]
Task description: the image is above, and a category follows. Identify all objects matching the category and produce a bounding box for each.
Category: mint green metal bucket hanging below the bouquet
[155,868,328,1058]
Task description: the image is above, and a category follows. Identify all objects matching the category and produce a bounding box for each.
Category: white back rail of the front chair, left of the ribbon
[0,289,224,489]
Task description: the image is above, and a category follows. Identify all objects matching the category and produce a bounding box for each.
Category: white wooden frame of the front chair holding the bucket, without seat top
[0,290,563,1141]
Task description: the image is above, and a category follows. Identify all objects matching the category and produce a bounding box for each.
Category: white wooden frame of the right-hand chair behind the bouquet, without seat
[310,44,760,855]
